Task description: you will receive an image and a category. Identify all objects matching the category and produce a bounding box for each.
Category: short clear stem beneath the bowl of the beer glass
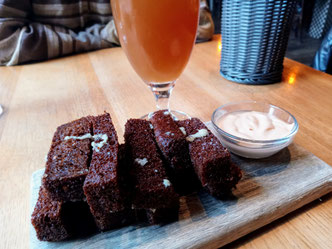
[149,81,175,110]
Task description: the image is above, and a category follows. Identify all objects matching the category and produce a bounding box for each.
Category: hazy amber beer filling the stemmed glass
[111,0,199,83]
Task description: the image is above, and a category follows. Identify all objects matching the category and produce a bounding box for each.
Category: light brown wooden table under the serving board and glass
[0,36,332,248]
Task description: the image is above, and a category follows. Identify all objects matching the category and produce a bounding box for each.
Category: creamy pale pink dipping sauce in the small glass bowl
[217,111,294,140]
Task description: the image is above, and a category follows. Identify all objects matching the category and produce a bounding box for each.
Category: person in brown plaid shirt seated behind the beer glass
[0,0,214,66]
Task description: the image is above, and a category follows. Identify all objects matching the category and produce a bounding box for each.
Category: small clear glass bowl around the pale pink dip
[211,101,299,158]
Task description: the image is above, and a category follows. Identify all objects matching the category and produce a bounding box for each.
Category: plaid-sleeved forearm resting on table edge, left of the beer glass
[0,0,119,66]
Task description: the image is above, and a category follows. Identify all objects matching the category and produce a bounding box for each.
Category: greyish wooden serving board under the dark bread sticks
[30,124,332,249]
